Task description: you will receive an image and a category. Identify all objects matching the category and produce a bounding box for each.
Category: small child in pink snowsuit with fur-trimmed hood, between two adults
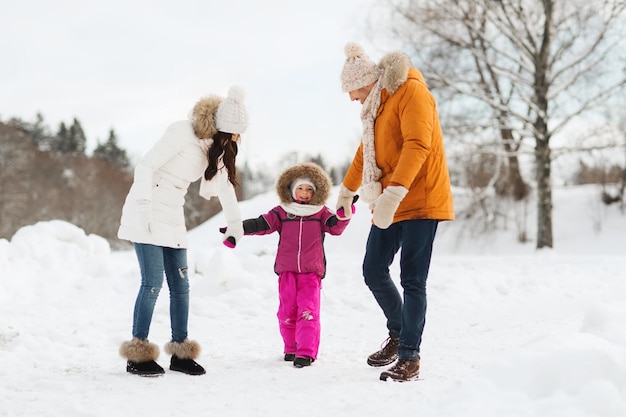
[227,163,354,368]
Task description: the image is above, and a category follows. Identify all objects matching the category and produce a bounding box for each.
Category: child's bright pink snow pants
[276,272,322,359]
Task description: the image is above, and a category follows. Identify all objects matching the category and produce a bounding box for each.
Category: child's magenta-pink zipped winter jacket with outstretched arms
[244,206,350,278]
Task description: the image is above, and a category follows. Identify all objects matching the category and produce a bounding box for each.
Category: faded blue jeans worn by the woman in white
[133,243,189,342]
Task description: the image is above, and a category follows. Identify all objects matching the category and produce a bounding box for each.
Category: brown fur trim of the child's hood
[276,162,332,206]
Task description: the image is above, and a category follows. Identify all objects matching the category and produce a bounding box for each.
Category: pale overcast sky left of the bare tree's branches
[0,0,386,169]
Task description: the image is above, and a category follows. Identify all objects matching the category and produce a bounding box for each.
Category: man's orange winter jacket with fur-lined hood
[343,57,454,223]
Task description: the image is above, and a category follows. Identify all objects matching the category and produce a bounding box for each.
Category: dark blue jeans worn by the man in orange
[363,219,439,359]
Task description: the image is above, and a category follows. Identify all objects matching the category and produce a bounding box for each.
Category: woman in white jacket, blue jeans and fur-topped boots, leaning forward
[118,86,248,376]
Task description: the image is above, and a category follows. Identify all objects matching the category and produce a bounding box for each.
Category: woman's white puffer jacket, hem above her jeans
[117,120,241,248]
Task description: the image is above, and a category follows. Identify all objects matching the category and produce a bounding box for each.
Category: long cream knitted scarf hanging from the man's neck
[361,75,383,203]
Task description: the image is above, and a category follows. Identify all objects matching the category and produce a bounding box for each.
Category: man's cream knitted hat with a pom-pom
[341,42,381,93]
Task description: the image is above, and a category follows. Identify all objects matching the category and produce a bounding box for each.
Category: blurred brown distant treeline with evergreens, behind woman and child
[0,114,343,248]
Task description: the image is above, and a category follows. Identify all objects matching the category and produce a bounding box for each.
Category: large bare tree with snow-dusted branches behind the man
[388,0,626,249]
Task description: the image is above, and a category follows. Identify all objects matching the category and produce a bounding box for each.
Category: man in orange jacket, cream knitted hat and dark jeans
[337,42,454,381]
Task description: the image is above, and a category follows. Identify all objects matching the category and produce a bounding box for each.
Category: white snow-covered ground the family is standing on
[0,187,626,417]
